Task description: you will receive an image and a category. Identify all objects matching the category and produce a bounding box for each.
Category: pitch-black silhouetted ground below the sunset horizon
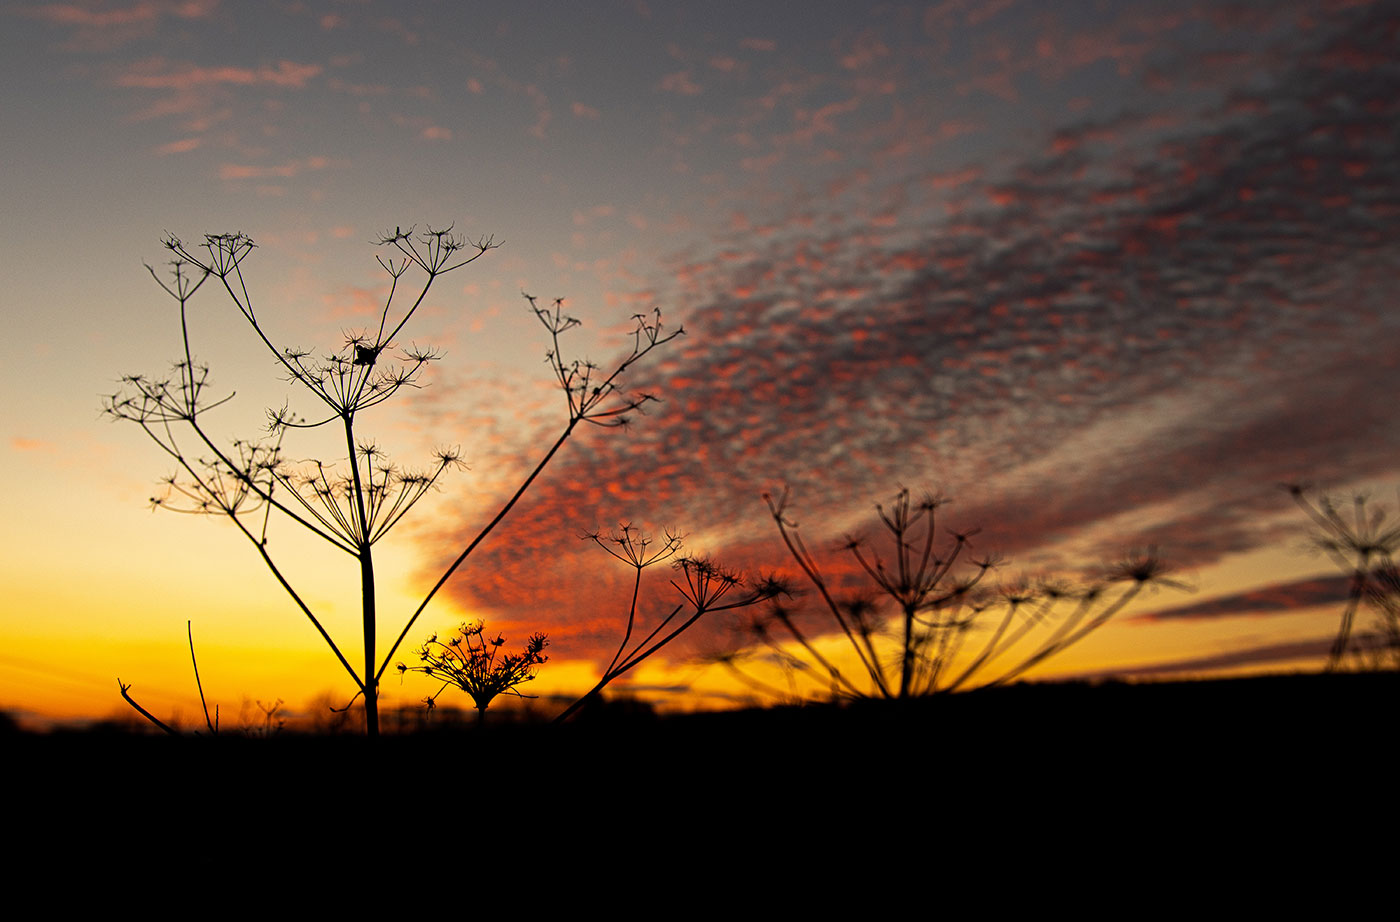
[13,674,1400,884]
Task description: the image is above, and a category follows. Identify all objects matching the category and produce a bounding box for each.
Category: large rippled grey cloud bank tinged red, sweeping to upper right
[425,6,1400,674]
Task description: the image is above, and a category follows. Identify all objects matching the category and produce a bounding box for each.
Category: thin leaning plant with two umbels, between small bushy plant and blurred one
[554,525,787,722]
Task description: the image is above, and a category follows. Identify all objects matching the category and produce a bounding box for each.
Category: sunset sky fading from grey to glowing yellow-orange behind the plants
[0,0,1400,722]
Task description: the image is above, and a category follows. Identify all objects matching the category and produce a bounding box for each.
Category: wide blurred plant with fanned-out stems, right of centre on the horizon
[714,490,1177,700]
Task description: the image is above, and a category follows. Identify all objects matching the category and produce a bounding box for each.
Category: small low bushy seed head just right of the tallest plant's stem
[399,621,549,723]
